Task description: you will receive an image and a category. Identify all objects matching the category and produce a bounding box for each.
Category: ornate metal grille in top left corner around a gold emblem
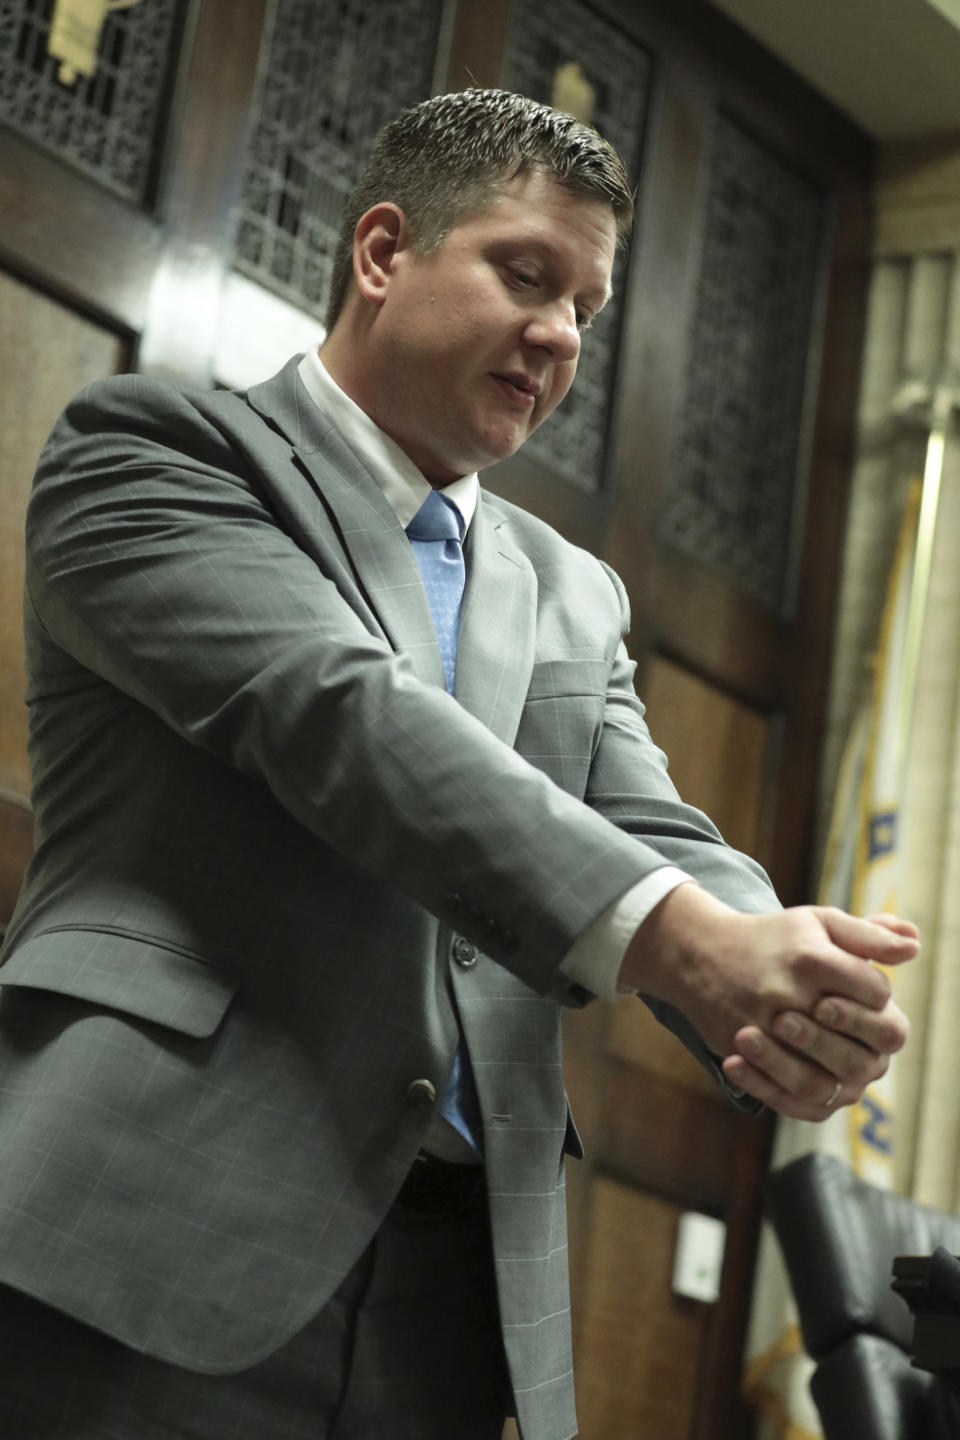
[0,0,181,204]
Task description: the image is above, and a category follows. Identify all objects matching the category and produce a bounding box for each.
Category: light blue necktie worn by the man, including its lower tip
[407,490,484,1152]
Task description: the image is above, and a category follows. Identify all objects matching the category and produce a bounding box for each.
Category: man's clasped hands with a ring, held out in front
[620,884,920,1120]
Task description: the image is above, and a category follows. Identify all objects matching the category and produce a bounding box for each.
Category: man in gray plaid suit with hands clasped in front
[0,91,915,1440]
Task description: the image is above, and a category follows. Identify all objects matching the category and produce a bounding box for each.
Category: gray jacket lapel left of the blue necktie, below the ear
[248,359,443,685]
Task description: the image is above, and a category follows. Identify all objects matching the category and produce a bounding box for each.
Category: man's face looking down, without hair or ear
[364,173,616,485]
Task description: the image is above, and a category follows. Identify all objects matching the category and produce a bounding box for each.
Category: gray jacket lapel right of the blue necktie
[456,491,537,744]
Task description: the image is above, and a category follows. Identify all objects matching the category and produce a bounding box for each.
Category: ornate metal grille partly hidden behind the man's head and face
[507,0,651,492]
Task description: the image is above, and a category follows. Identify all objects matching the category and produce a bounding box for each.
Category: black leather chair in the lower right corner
[766,1155,960,1440]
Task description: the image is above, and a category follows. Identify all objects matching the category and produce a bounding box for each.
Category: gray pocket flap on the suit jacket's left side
[0,929,239,1040]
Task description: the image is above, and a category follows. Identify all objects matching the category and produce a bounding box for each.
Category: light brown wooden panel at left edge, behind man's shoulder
[0,272,125,798]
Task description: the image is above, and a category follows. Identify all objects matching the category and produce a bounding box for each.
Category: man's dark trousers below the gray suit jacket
[0,1162,512,1440]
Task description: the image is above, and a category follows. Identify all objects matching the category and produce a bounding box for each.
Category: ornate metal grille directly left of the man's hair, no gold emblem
[235,0,442,315]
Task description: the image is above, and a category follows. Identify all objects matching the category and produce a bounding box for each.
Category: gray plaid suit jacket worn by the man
[0,361,776,1440]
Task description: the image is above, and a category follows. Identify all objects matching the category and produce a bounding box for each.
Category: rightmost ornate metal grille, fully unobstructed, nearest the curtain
[659,114,823,611]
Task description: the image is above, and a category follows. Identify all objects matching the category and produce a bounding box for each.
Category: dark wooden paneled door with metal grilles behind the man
[0,0,872,1440]
